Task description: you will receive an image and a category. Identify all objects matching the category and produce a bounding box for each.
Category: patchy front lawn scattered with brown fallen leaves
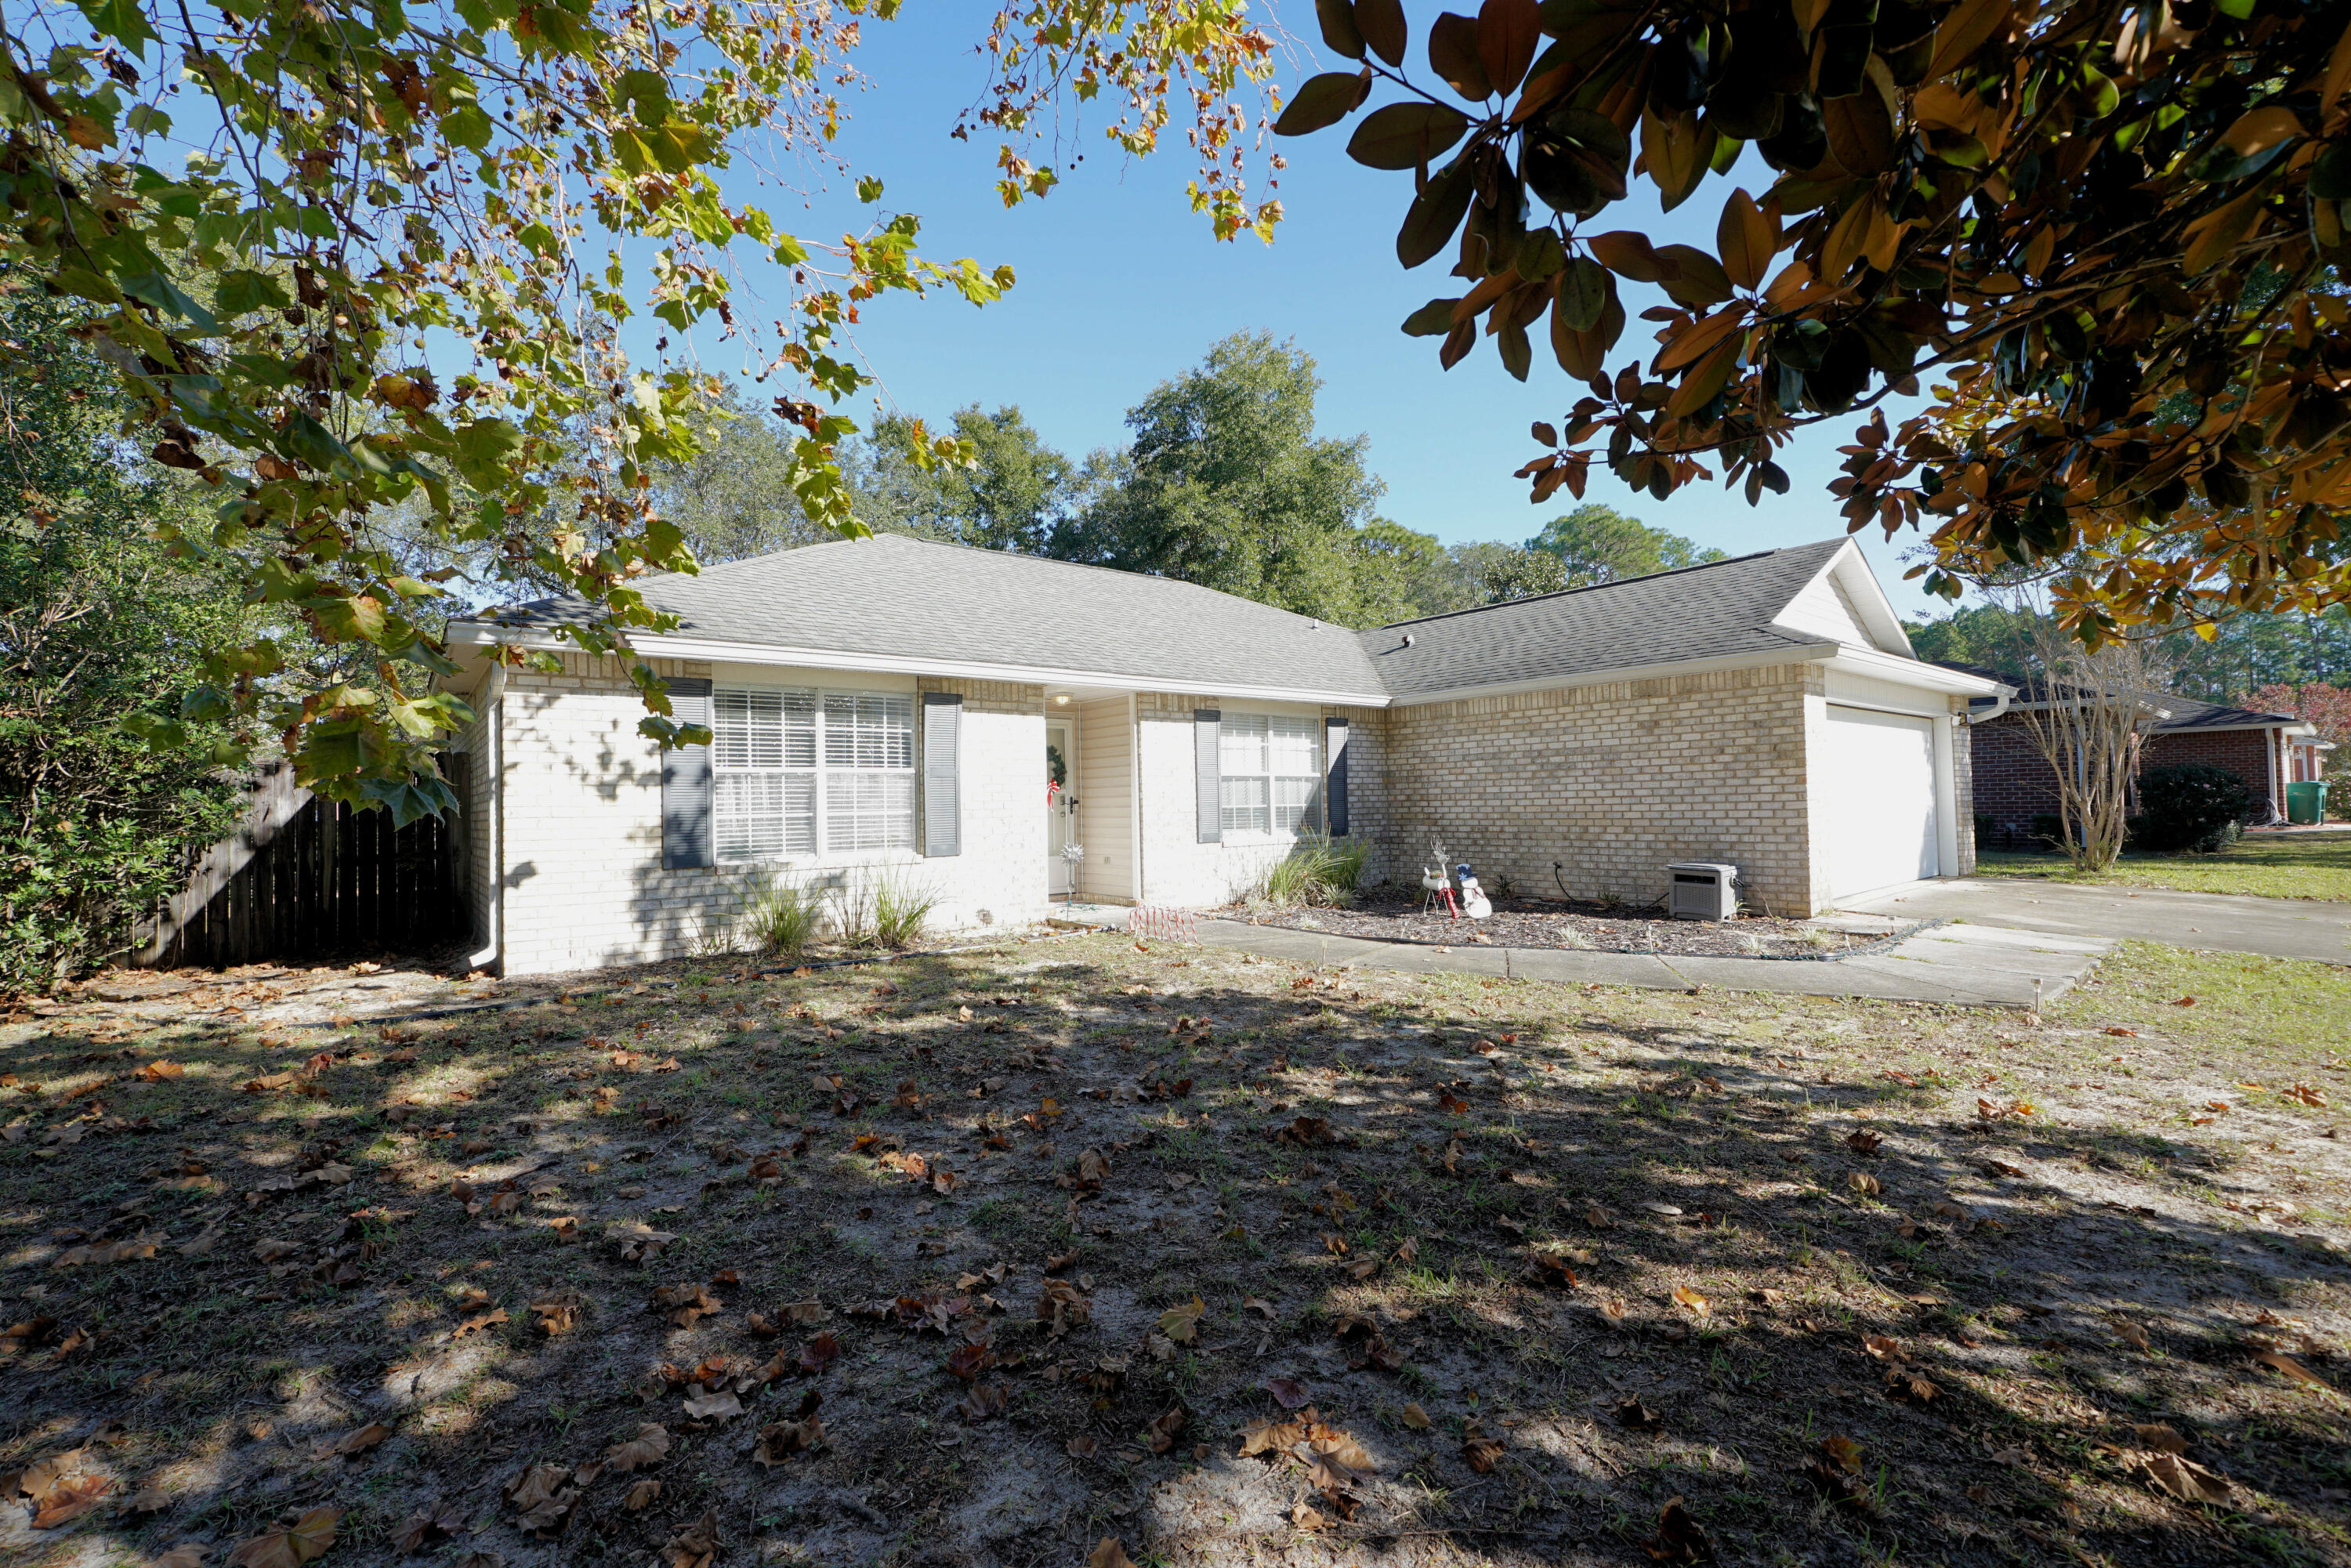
[0,936,2351,1568]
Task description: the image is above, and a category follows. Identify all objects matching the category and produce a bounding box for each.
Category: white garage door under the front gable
[1815,708,1935,898]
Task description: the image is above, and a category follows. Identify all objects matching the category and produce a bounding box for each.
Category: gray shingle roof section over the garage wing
[1357,538,1846,696]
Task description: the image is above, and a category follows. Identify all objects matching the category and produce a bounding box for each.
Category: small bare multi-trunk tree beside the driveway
[2010,602,2161,872]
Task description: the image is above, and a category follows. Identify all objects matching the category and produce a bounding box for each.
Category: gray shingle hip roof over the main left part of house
[458,534,1382,696]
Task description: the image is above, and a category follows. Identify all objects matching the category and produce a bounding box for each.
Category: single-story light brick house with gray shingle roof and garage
[449,536,2001,973]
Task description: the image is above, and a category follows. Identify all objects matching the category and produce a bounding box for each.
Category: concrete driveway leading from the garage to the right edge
[1838,877,2351,964]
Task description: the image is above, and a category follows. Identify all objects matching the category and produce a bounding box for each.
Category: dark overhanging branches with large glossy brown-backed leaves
[1274,0,2351,644]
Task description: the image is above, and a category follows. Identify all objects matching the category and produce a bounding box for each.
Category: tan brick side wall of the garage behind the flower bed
[1349,663,1824,914]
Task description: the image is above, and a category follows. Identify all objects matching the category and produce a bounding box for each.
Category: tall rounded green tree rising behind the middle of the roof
[1046,331,1382,625]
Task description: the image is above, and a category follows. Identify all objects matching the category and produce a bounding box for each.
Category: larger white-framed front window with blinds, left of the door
[710,686,915,863]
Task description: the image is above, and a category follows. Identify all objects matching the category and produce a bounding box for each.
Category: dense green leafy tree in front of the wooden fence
[0,280,268,994]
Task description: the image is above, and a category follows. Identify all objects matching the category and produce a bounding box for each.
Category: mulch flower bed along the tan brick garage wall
[1234,889,1878,959]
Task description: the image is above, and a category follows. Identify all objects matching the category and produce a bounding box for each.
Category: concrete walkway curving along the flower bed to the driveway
[1199,919,2114,1006]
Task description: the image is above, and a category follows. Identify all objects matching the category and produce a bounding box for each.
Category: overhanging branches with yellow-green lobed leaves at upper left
[0,0,1279,820]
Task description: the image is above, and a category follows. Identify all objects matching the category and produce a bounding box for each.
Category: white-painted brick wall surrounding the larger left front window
[477,654,1046,976]
